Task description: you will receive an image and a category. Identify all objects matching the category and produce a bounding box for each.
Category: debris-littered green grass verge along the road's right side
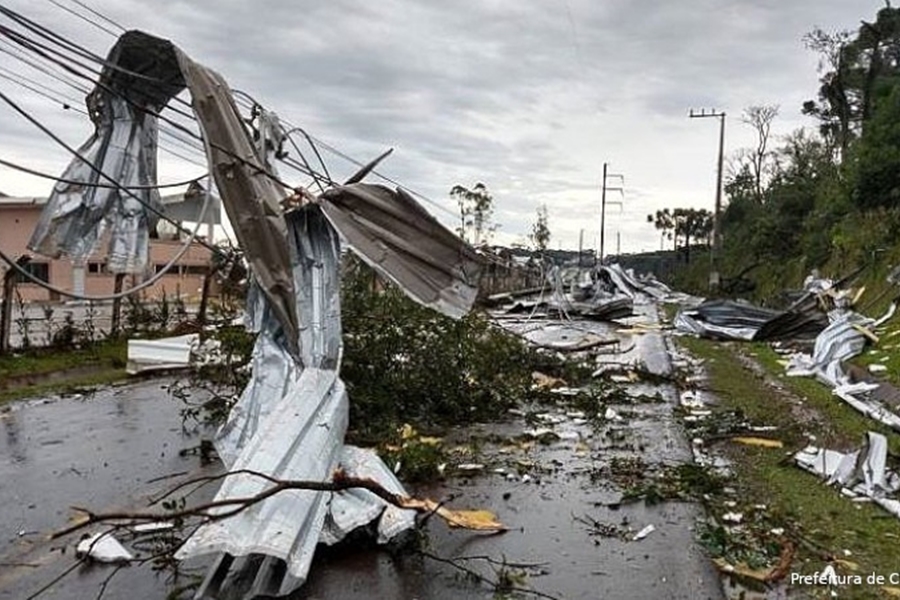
[678,338,900,599]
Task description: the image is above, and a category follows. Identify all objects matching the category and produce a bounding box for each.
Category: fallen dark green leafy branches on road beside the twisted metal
[341,255,535,433]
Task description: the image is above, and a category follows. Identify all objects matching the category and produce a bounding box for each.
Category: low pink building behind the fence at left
[0,194,219,302]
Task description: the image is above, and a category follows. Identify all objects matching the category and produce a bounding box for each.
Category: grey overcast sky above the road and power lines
[0,0,884,253]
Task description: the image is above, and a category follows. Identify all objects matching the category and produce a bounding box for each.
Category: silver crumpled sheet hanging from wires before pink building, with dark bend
[28,31,184,273]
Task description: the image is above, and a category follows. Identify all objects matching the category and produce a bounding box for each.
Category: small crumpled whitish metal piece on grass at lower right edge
[794,431,900,518]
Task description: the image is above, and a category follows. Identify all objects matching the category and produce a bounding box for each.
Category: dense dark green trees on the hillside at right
[675,5,900,301]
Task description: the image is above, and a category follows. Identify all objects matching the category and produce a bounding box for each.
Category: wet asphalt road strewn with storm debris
[0,306,722,600]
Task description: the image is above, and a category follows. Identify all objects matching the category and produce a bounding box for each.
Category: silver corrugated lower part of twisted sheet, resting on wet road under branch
[177,205,414,594]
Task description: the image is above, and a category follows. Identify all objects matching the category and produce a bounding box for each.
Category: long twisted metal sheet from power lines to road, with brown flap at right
[45,32,480,593]
